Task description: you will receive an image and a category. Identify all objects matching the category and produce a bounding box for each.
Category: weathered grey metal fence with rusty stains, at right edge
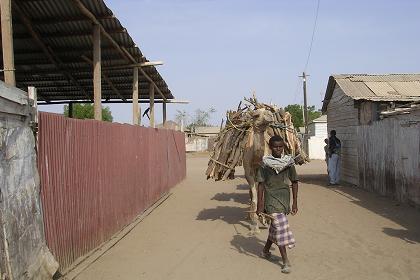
[358,114,420,206]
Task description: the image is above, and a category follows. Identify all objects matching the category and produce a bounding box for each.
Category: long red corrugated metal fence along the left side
[38,113,186,271]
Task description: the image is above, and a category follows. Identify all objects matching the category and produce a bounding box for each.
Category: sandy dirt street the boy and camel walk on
[77,155,420,280]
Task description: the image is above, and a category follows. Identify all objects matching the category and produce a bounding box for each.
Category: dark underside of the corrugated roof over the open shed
[0,0,174,101]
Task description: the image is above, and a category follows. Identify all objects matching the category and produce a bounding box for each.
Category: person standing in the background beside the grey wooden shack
[328,130,341,185]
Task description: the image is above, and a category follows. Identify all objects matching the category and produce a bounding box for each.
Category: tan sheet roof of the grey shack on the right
[322,74,420,112]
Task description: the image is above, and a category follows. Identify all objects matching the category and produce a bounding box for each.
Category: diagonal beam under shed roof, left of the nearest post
[12,1,91,99]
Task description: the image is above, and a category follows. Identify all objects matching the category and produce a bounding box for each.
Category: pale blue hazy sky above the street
[41,0,420,125]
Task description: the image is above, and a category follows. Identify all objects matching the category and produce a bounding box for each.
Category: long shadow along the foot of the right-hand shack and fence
[299,174,420,244]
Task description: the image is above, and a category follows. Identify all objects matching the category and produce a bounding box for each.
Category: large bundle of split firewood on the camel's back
[206,97,307,181]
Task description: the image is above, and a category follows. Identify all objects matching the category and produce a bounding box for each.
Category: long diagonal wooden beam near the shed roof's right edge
[73,0,166,100]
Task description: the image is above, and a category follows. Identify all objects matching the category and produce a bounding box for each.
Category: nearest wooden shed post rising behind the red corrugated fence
[93,24,102,121]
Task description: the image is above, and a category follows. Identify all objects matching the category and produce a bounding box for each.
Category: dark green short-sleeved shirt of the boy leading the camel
[257,166,298,214]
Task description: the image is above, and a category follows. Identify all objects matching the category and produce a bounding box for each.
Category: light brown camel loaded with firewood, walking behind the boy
[243,108,305,233]
